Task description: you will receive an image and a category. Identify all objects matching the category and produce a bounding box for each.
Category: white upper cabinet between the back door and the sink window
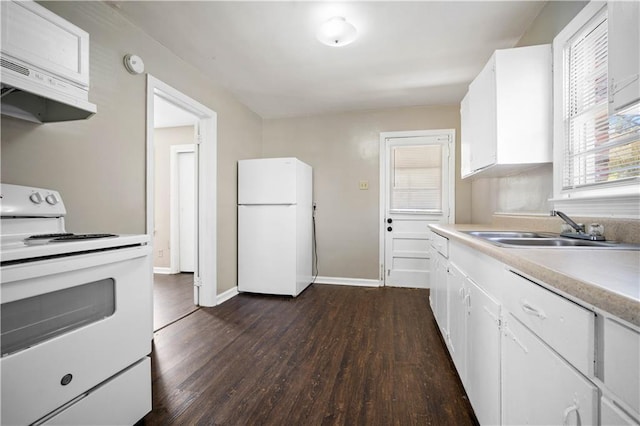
[461,45,553,177]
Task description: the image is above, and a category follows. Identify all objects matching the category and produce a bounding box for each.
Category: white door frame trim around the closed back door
[378,129,456,287]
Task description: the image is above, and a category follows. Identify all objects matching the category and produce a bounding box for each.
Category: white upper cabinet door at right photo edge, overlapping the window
[607,1,640,114]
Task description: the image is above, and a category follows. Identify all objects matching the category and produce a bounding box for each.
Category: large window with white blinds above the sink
[562,10,640,190]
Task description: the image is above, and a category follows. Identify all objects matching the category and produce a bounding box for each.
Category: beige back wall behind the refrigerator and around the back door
[262,105,470,279]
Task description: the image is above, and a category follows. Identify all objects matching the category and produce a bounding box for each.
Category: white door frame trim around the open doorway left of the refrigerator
[146,74,218,306]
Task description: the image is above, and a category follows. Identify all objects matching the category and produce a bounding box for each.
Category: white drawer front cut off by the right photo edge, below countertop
[603,318,640,413]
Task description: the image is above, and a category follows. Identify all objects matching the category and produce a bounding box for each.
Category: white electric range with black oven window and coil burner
[0,184,153,425]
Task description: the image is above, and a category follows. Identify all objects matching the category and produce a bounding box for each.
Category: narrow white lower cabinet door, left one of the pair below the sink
[447,264,467,383]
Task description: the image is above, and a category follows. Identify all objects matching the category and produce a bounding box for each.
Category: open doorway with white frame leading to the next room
[146,75,217,330]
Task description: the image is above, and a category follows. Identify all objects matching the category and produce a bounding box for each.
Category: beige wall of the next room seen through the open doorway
[153,126,194,268]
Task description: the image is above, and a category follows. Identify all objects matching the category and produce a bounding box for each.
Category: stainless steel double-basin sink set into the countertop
[465,231,640,250]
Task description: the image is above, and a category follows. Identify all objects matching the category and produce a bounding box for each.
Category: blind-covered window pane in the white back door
[390,144,442,212]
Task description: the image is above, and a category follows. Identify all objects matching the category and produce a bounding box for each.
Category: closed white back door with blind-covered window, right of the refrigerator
[382,131,454,288]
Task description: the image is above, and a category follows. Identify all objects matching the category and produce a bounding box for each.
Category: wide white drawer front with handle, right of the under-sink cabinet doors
[504,271,595,376]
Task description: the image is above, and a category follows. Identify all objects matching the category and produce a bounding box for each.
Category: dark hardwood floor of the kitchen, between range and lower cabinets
[140,284,477,425]
